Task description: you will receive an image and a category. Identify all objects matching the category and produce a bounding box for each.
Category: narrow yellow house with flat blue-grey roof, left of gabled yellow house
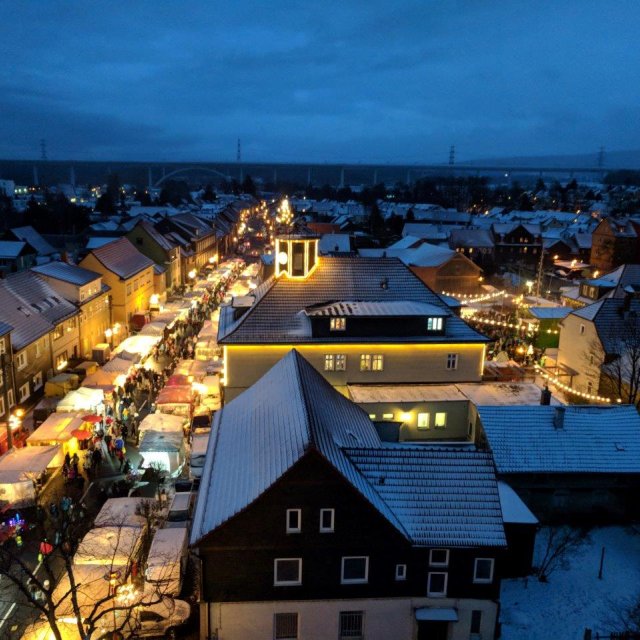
[31,261,113,359]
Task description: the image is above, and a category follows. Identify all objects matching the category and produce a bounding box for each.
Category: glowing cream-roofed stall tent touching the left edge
[0,445,64,508]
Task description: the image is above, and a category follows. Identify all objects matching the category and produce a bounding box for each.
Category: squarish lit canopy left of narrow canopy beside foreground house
[73,526,143,567]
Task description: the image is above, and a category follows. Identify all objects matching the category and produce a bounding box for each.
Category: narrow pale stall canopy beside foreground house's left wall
[146,527,189,596]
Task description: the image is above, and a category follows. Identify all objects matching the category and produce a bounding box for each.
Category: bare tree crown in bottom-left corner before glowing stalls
[0,499,174,640]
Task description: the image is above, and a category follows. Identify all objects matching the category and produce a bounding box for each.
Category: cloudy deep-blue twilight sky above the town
[0,0,640,163]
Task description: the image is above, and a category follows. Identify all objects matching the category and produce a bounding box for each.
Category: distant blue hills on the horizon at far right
[458,149,640,170]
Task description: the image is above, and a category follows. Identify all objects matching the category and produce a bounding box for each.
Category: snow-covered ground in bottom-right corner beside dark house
[501,527,640,640]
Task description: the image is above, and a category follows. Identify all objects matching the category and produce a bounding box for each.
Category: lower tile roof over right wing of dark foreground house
[346,445,506,547]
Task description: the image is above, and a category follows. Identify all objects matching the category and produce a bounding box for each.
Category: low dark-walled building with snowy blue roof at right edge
[478,405,640,524]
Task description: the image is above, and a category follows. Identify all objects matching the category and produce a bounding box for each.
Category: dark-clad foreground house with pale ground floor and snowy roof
[191,351,506,640]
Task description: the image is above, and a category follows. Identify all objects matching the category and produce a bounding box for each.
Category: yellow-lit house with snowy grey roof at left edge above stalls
[0,271,79,408]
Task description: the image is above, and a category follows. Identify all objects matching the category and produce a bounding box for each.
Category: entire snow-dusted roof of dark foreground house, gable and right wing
[191,350,505,546]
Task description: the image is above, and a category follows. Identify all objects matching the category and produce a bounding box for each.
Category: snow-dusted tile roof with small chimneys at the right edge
[478,405,640,473]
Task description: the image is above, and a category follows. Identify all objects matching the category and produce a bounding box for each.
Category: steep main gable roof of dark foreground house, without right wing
[191,350,405,543]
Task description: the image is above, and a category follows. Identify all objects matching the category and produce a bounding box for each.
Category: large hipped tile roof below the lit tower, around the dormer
[218,256,487,344]
